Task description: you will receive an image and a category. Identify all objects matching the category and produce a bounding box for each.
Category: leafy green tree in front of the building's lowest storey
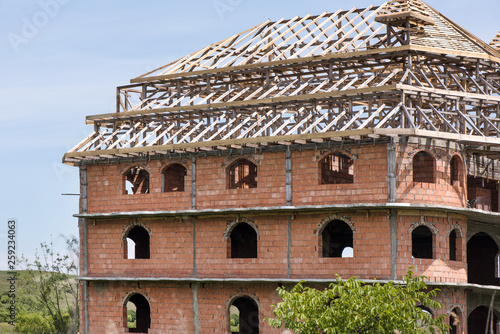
[268,271,449,334]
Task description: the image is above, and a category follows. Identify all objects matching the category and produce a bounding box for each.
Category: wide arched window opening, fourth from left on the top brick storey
[320,152,354,184]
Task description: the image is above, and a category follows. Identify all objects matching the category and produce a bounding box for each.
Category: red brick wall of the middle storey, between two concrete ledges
[83,210,467,283]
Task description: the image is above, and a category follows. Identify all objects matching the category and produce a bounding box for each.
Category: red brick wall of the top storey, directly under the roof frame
[87,144,467,213]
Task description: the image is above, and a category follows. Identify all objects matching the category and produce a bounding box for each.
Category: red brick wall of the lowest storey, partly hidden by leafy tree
[81,282,467,334]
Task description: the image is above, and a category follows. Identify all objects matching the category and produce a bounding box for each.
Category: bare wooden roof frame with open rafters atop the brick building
[64,0,500,184]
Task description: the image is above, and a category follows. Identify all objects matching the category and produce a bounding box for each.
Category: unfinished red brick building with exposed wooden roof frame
[64,0,500,334]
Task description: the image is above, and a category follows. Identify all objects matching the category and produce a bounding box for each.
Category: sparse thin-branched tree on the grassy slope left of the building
[15,238,79,334]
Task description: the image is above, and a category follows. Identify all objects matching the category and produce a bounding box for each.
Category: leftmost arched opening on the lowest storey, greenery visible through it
[123,293,151,333]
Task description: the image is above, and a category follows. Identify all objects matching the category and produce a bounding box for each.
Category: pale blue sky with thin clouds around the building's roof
[0,0,500,269]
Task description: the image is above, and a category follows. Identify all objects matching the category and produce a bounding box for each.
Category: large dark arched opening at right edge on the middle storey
[467,232,499,286]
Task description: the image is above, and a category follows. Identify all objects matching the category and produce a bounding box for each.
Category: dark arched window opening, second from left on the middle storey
[228,223,257,259]
